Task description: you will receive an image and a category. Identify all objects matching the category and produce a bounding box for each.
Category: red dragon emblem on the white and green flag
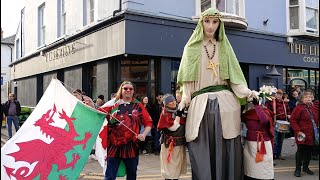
[5,105,92,180]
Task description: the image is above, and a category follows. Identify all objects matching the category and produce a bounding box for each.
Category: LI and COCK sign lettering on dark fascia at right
[289,43,319,64]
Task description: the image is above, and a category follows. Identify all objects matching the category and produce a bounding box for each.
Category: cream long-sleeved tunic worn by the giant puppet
[182,39,253,142]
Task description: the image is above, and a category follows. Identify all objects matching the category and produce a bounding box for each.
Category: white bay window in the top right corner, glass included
[287,0,319,36]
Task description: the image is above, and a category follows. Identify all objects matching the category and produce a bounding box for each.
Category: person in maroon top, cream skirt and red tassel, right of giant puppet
[241,99,274,180]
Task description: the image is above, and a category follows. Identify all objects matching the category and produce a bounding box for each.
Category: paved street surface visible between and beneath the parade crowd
[1,125,319,180]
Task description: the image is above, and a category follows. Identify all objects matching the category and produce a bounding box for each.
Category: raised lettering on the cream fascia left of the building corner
[45,43,76,62]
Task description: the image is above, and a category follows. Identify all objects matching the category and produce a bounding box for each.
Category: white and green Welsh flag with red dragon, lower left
[1,79,106,180]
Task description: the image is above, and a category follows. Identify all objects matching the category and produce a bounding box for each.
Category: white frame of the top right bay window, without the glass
[286,0,319,37]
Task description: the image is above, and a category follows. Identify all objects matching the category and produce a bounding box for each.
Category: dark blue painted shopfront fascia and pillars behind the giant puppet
[125,11,319,92]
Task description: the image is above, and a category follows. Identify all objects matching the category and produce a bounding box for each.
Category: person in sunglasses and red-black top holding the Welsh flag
[99,81,152,180]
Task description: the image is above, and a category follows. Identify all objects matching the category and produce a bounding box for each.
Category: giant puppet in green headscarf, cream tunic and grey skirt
[178,8,256,180]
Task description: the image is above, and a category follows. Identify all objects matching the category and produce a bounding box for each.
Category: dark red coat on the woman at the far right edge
[290,104,319,146]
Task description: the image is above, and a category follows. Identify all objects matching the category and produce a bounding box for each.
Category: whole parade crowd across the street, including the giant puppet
[1,8,319,180]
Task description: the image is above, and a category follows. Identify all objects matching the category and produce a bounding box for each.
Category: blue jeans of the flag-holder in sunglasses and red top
[104,157,139,180]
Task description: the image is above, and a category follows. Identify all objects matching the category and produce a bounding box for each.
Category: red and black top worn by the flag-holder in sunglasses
[99,99,152,158]
